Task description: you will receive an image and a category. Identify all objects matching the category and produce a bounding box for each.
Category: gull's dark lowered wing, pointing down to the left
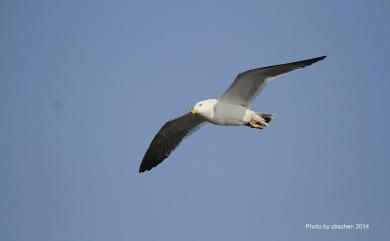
[139,113,206,172]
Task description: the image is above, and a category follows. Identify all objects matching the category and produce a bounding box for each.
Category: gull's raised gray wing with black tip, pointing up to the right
[219,56,326,106]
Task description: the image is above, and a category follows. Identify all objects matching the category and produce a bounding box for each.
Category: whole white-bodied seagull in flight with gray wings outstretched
[139,55,326,173]
